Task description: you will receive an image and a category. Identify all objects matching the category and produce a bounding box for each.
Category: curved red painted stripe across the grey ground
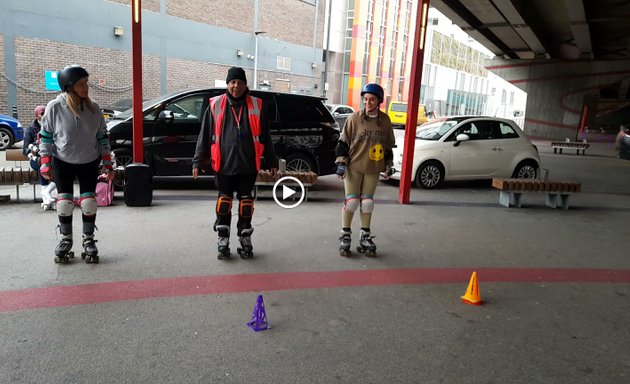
[0,268,630,312]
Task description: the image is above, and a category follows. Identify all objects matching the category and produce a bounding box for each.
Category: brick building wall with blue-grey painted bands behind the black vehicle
[0,0,325,123]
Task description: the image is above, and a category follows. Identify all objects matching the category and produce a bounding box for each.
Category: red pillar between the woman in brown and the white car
[398,0,430,204]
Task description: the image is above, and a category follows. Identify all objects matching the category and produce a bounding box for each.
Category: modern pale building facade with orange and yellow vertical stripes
[324,0,527,127]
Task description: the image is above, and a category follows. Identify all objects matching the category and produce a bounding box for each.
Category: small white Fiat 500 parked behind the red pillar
[391,116,540,189]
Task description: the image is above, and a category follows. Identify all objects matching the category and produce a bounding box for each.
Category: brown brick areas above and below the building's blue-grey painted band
[0,0,325,120]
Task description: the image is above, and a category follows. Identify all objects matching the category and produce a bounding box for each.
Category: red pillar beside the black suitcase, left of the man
[131,0,144,163]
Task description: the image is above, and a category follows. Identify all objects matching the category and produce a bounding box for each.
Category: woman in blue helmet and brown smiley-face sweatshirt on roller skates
[335,83,395,256]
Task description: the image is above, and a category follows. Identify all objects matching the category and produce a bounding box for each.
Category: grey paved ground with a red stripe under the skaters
[0,142,630,384]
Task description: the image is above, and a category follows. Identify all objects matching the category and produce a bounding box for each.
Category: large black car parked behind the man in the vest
[107,88,339,176]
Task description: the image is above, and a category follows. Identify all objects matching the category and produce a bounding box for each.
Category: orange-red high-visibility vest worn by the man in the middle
[210,94,265,173]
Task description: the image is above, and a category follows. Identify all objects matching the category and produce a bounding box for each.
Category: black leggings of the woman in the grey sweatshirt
[52,156,101,234]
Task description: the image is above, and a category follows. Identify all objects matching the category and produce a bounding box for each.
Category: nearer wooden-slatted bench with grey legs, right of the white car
[492,178,582,209]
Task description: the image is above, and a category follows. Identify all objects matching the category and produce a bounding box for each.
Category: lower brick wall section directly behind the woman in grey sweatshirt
[14,37,160,119]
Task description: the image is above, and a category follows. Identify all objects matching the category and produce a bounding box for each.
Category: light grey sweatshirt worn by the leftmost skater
[40,93,111,164]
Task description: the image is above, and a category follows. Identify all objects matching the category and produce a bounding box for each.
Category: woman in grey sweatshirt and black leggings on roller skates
[39,65,114,264]
